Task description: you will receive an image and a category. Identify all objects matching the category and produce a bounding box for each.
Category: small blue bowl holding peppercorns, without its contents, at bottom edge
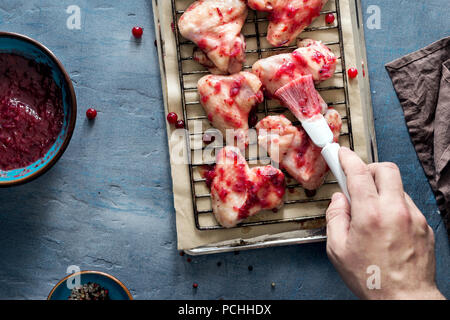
[47,271,133,300]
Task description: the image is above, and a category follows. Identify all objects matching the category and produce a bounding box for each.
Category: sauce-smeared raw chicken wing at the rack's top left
[178,0,248,74]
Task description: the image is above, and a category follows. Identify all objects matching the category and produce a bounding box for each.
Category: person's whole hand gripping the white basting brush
[327,148,444,299]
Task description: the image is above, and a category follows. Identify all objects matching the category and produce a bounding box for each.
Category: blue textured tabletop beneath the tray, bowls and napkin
[0,0,450,299]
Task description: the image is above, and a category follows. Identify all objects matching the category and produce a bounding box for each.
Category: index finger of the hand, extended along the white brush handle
[339,147,378,209]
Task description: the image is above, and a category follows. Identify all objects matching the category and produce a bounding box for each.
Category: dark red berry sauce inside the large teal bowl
[0,53,64,171]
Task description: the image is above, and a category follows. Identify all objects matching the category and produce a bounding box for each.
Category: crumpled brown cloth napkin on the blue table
[386,37,450,235]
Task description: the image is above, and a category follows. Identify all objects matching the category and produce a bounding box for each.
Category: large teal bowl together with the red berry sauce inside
[0,32,77,187]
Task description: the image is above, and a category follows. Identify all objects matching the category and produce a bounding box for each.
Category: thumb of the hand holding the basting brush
[327,193,350,248]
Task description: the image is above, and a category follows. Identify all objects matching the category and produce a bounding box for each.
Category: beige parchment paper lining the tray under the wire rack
[153,0,373,250]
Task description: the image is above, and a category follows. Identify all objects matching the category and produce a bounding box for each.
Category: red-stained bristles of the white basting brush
[275,75,323,121]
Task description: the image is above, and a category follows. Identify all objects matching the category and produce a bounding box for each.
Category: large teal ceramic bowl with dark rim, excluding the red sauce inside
[0,32,77,187]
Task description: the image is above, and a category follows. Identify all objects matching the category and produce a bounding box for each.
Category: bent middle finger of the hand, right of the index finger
[369,162,404,201]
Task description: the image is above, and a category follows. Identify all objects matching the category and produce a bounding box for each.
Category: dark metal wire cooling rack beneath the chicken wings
[171,0,353,230]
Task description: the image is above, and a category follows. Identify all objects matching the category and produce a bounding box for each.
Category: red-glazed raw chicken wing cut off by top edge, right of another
[248,0,328,47]
